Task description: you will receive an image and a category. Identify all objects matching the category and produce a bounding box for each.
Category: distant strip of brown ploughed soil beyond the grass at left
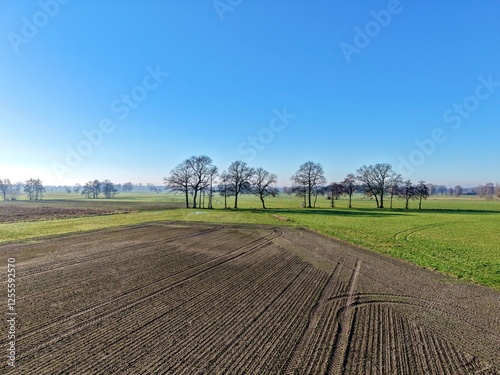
[0,199,182,223]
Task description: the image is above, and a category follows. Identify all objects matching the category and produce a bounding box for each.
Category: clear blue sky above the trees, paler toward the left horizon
[0,0,500,186]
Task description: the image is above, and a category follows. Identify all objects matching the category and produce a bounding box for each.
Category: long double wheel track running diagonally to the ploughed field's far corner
[15,232,282,358]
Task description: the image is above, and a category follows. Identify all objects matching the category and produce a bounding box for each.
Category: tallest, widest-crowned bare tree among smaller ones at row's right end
[357,163,395,208]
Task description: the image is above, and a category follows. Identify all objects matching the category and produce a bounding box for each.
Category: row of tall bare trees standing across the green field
[163,159,429,209]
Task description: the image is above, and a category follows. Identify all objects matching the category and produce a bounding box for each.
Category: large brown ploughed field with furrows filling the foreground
[0,223,500,375]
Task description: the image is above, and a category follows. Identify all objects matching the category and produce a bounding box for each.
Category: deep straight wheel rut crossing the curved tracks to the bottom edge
[327,259,361,374]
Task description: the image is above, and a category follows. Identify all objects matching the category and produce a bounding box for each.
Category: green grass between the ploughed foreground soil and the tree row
[0,209,500,290]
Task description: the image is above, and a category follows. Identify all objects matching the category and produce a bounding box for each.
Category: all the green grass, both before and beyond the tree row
[0,193,500,290]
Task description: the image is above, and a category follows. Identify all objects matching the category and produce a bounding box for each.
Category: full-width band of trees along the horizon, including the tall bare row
[0,164,500,209]
